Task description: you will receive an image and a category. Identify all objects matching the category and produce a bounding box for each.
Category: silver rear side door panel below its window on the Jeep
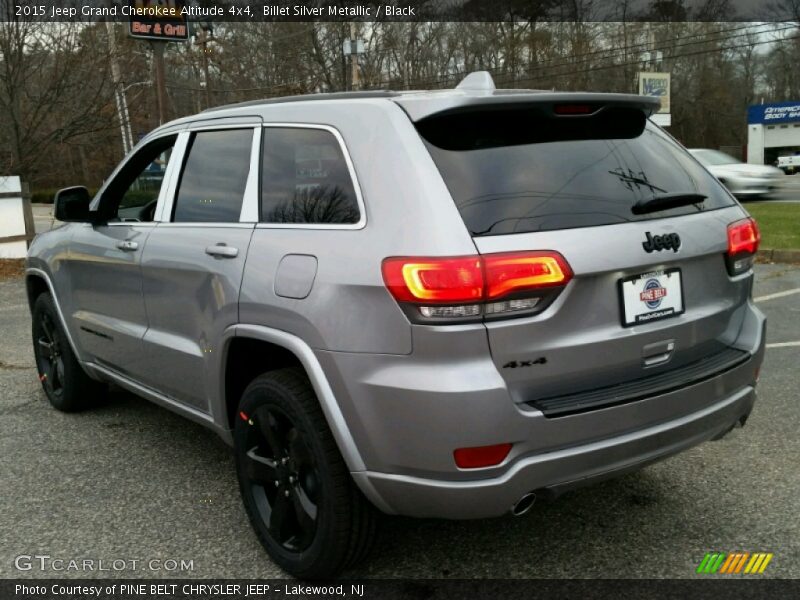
[140,223,253,415]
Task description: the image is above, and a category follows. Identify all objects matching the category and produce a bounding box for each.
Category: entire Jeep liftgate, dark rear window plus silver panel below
[415,95,757,414]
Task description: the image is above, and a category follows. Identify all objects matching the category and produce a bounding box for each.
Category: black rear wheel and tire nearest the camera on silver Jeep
[234,368,377,579]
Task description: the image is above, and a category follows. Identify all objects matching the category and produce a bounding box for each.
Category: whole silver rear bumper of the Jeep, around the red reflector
[317,302,766,519]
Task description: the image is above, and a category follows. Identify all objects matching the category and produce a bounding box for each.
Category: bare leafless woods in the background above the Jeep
[0,0,800,191]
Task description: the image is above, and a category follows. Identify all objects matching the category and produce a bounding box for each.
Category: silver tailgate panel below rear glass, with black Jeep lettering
[474,207,750,405]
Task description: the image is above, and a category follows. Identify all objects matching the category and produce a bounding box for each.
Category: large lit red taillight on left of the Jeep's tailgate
[382,252,572,322]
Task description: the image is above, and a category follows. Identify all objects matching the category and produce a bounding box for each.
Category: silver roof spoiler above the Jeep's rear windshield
[391,90,661,122]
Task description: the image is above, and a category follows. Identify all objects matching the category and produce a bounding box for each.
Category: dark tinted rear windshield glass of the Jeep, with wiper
[417,107,734,236]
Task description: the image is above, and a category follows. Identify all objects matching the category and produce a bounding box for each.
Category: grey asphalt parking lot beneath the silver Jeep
[0,264,800,578]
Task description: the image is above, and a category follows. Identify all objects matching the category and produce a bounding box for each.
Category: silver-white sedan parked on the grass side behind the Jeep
[689,149,783,198]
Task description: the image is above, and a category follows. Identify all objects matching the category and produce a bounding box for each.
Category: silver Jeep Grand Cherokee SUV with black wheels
[27,73,765,578]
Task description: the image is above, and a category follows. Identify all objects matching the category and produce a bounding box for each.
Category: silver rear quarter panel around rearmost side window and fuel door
[240,99,476,354]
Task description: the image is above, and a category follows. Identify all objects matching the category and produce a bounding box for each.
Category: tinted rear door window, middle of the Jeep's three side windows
[172,129,253,223]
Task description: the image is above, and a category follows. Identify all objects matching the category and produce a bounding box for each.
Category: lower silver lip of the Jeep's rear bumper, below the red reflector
[354,380,756,519]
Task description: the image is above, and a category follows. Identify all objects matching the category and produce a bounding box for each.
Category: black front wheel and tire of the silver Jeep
[31,293,105,412]
